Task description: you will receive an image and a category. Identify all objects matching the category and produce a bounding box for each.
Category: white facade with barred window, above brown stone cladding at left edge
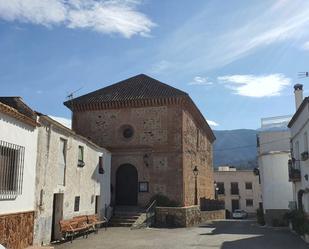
[0,104,37,215]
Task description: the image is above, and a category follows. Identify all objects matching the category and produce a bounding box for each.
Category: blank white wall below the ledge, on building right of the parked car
[259,152,293,209]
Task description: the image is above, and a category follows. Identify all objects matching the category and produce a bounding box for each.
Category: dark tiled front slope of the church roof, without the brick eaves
[64,74,188,107]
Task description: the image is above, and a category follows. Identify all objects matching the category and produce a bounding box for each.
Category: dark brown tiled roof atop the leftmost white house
[0,97,37,121]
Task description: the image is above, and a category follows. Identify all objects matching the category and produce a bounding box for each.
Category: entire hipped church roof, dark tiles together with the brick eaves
[64,74,215,142]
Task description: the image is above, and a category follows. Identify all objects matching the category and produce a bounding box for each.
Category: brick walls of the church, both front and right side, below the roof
[66,76,214,206]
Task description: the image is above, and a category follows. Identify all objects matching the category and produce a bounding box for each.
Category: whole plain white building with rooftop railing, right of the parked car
[257,116,293,225]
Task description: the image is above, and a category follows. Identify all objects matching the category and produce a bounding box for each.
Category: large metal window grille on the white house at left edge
[0,140,25,199]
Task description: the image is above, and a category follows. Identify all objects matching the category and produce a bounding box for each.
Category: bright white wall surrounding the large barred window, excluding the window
[0,113,37,214]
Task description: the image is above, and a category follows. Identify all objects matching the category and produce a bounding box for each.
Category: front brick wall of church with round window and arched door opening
[73,106,183,206]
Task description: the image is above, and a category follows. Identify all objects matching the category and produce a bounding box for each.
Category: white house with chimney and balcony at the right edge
[288,84,309,215]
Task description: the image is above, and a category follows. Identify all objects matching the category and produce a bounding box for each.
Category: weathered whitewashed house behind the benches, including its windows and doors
[34,114,111,245]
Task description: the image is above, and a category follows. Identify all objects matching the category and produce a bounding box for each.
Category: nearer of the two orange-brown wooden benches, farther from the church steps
[59,219,90,243]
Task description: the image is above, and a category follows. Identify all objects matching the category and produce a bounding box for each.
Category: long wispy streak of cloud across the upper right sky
[152,0,309,74]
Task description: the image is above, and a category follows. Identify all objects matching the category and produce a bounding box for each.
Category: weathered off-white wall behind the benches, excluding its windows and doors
[34,118,111,244]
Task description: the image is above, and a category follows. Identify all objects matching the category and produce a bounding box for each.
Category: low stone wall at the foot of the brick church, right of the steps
[155,206,225,227]
